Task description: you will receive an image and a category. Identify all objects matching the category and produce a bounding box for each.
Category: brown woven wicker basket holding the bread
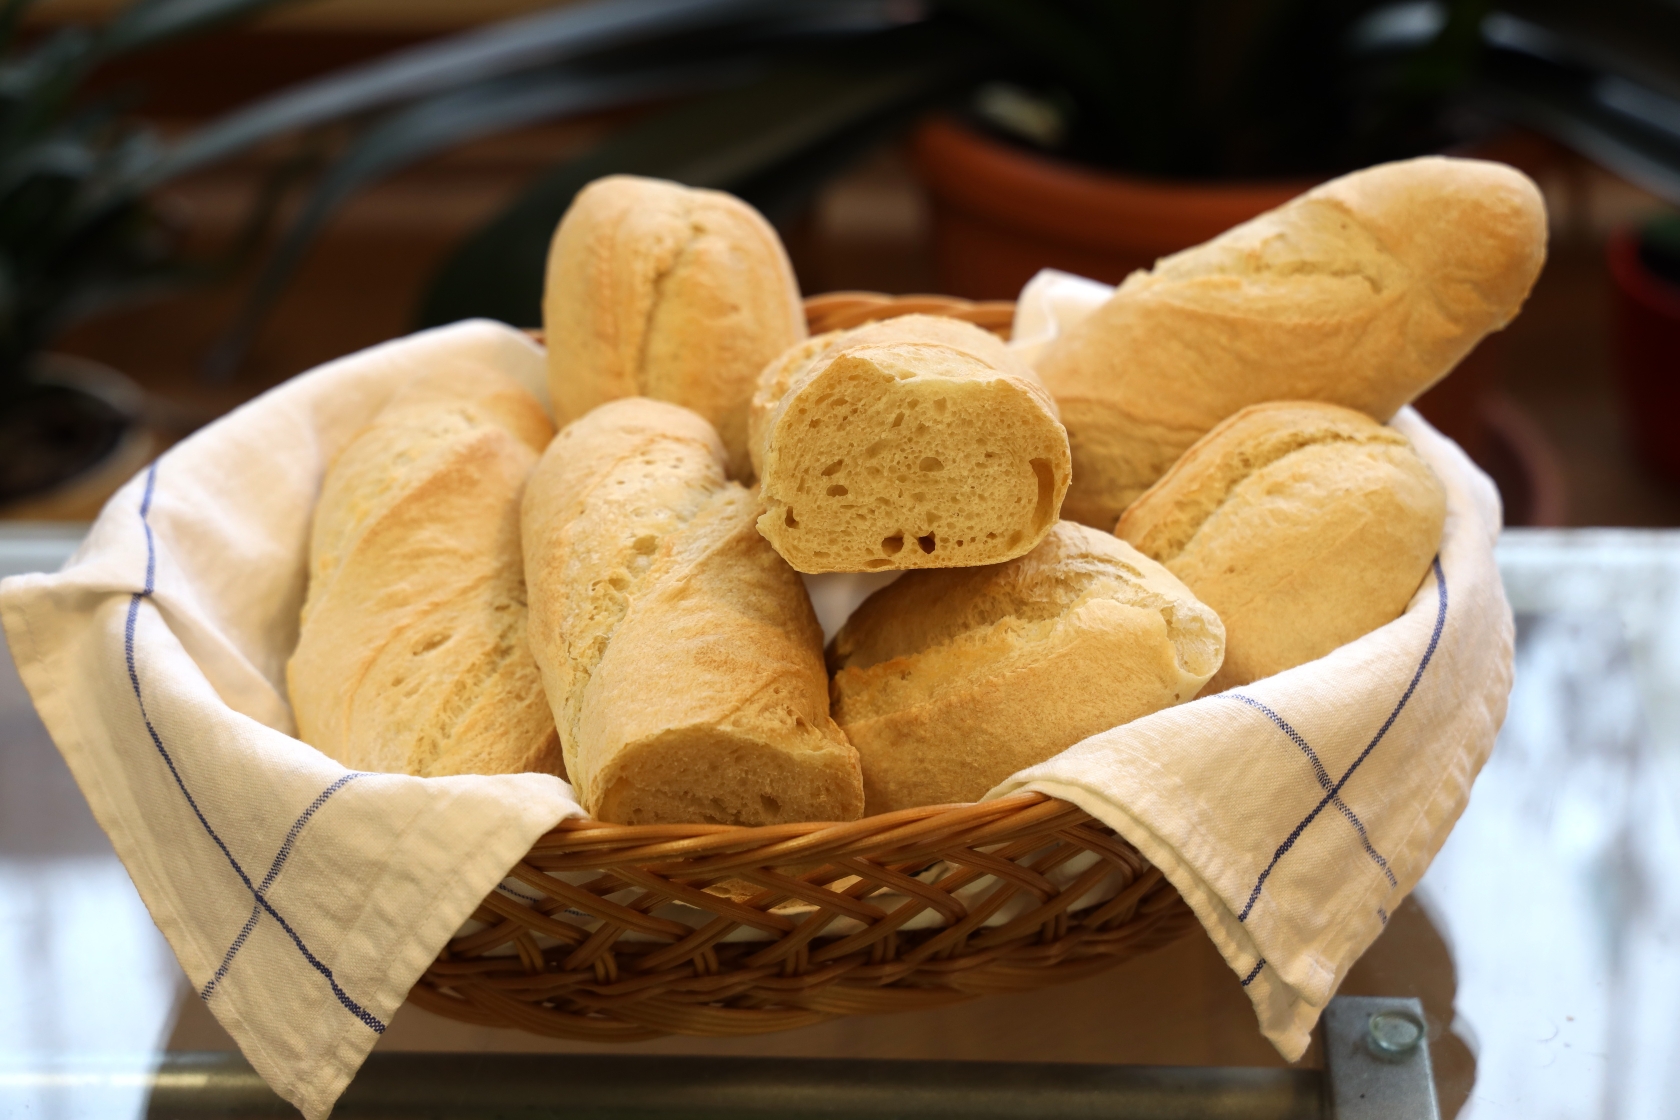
[410,292,1194,1043]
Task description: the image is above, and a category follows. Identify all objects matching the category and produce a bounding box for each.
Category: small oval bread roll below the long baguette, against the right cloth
[1116,401,1446,692]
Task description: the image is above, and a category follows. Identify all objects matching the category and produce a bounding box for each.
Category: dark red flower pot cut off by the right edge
[1609,230,1680,484]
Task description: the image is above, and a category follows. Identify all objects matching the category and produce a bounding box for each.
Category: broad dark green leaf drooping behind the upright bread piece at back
[420,27,993,326]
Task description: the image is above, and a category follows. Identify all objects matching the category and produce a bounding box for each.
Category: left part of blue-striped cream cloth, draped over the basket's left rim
[0,322,583,1120]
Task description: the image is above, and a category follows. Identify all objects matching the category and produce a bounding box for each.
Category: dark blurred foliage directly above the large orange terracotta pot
[942,0,1488,178]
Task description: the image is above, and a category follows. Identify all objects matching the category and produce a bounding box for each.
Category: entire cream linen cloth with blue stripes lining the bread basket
[0,295,1512,1120]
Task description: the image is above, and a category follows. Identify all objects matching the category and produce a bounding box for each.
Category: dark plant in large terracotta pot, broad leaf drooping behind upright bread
[420,0,1487,332]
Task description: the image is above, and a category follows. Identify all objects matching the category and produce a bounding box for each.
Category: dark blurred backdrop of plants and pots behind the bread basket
[0,0,1680,526]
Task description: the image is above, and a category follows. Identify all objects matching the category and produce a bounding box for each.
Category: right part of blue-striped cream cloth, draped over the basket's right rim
[986,270,1514,1061]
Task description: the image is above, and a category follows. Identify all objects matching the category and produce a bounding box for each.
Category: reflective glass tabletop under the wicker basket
[0,526,1680,1120]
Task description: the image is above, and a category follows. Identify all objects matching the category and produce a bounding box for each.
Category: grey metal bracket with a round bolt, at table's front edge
[1324,996,1441,1120]
